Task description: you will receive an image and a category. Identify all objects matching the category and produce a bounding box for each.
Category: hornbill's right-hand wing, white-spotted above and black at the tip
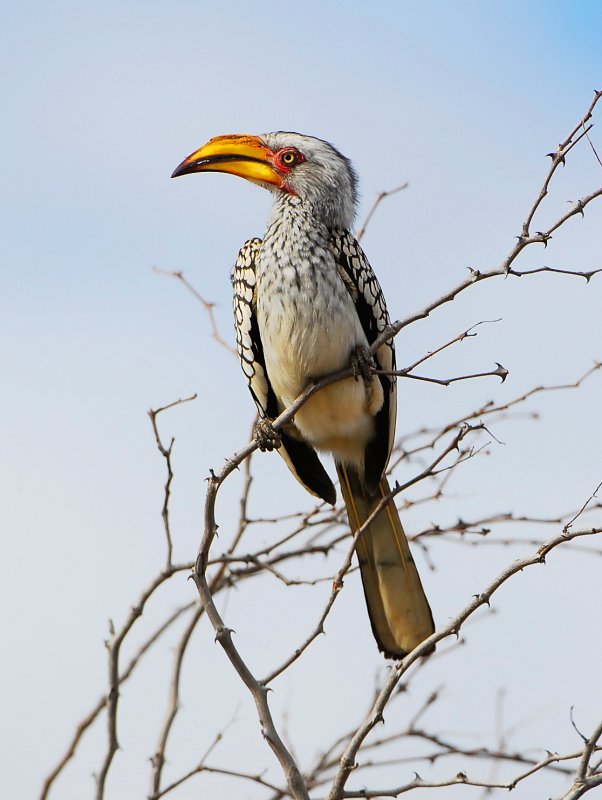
[331,230,397,488]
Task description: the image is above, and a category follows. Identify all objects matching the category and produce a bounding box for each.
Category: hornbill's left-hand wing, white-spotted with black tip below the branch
[232,234,336,505]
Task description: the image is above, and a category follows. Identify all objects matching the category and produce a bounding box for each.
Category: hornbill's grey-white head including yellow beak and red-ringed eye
[172,131,357,228]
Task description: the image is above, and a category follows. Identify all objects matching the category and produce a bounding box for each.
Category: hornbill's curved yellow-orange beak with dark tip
[171,134,285,189]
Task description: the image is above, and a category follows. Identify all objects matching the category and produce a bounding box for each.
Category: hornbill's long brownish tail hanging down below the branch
[336,463,435,658]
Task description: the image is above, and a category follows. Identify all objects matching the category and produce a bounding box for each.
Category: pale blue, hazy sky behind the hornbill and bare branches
[0,0,602,800]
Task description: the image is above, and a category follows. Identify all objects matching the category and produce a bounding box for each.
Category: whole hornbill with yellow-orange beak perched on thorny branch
[172,132,434,658]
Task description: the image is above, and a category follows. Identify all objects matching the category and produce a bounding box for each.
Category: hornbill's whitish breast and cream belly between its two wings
[257,236,383,465]
